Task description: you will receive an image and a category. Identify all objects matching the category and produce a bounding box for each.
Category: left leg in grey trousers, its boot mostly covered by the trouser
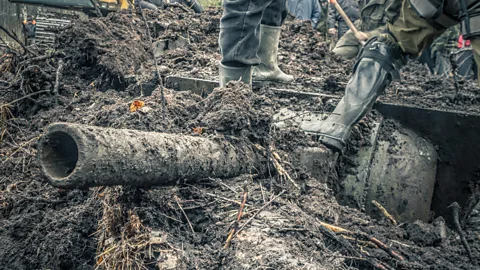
[218,0,272,86]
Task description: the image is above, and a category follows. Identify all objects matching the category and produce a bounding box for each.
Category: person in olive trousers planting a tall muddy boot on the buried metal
[301,0,480,152]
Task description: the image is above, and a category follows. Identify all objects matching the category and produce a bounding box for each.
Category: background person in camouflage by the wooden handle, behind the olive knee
[333,0,394,60]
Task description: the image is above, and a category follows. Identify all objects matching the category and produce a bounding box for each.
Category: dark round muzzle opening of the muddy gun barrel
[40,131,78,178]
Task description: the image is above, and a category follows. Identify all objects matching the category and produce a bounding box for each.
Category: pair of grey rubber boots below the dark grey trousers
[220,24,294,87]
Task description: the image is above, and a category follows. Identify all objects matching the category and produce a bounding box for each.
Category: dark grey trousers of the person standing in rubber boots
[218,0,287,67]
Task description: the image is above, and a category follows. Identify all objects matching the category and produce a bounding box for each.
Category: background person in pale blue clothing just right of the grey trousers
[287,0,321,29]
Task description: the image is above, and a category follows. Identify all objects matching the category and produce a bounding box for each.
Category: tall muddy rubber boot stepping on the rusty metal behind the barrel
[300,36,406,152]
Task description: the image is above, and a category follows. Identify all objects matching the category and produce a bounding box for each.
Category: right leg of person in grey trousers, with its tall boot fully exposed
[253,0,294,83]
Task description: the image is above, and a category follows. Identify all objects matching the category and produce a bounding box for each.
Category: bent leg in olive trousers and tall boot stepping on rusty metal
[301,0,443,152]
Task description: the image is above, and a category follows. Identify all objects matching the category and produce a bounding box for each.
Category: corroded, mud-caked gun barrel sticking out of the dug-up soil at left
[38,123,266,188]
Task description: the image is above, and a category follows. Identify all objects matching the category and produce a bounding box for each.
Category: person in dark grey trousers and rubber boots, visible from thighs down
[219,0,293,87]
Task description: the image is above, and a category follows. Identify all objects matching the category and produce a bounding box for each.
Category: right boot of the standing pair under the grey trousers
[253,24,294,83]
